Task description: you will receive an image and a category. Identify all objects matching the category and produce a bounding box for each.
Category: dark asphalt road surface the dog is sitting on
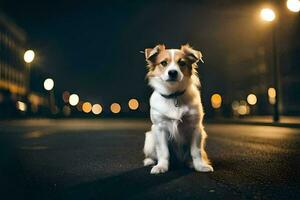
[0,120,300,200]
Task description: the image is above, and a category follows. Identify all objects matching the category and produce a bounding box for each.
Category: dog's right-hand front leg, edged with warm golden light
[191,128,213,172]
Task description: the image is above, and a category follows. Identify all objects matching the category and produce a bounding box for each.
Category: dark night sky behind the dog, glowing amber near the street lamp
[0,0,299,111]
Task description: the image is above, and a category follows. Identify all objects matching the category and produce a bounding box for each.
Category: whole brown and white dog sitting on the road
[143,44,213,174]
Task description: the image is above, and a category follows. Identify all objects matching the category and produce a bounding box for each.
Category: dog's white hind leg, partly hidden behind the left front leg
[144,131,156,166]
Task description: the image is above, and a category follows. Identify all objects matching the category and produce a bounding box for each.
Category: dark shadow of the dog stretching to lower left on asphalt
[55,167,192,199]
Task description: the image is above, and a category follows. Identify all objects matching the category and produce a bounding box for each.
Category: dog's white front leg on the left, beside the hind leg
[151,124,169,174]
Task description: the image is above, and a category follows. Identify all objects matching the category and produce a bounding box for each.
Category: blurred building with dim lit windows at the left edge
[0,12,45,118]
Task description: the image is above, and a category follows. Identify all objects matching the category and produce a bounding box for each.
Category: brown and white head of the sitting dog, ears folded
[144,45,203,93]
